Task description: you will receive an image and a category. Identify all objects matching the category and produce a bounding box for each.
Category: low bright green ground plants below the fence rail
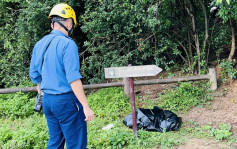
[0,83,236,149]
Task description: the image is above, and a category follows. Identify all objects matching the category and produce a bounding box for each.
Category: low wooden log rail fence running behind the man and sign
[0,68,217,95]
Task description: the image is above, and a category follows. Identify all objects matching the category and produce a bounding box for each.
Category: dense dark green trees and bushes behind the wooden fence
[0,0,237,87]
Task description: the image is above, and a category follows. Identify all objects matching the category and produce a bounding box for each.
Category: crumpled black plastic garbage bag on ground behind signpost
[123,106,182,132]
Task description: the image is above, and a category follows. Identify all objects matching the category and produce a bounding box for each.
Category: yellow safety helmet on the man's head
[49,3,77,26]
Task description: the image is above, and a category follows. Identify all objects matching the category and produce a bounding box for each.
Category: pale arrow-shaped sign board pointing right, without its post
[104,65,162,78]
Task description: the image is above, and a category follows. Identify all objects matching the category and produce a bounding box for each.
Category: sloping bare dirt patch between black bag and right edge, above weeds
[180,82,237,135]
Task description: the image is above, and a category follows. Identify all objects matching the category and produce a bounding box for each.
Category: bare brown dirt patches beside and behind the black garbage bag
[135,70,237,149]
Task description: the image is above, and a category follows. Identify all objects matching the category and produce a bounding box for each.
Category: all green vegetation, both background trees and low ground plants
[0,0,237,149]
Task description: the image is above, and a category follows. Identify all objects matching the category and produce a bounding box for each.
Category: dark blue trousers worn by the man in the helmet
[43,92,87,149]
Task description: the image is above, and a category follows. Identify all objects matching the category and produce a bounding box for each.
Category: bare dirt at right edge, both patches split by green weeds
[177,81,237,149]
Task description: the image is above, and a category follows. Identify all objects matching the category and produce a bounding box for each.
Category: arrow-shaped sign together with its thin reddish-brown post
[105,65,162,137]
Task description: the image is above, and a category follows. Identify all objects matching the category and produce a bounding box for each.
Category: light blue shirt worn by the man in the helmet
[29,30,82,94]
